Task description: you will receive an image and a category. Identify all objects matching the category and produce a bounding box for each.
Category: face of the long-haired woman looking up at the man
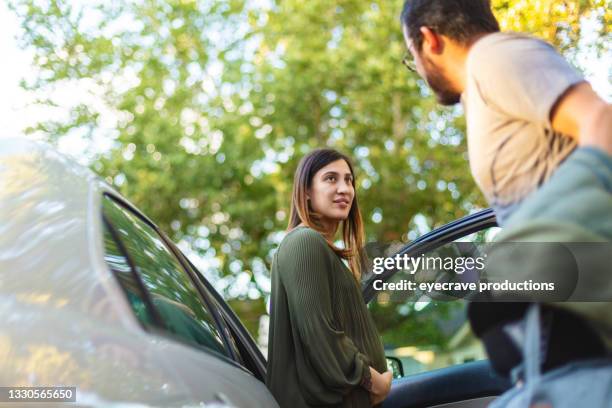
[308,159,355,226]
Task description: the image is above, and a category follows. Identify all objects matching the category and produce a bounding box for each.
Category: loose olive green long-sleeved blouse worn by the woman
[267,227,387,408]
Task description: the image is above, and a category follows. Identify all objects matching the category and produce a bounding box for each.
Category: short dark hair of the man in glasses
[401,0,499,50]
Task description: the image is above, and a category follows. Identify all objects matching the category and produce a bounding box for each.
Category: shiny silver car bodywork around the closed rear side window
[0,139,277,407]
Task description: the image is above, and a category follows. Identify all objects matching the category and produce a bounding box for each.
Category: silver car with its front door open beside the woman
[0,138,510,408]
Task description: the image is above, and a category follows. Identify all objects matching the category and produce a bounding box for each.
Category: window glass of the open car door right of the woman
[368,227,499,376]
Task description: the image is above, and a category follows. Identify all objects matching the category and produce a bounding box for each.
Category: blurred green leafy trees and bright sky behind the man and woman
[0,0,612,370]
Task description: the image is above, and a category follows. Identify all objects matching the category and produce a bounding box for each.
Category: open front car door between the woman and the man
[363,210,510,408]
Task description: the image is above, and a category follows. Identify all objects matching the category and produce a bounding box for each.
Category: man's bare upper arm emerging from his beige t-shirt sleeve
[550,82,612,155]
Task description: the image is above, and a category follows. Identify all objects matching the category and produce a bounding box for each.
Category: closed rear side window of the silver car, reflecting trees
[103,196,231,357]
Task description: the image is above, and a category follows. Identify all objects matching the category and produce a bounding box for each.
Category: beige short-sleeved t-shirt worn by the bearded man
[462,33,583,221]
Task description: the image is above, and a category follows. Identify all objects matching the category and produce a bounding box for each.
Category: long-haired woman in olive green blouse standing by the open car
[267,149,391,408]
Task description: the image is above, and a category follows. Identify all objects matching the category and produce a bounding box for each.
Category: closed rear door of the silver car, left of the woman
[103,195,277,407]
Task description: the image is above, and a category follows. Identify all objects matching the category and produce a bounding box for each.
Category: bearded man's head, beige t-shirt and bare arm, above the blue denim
[401,0,612,224]
